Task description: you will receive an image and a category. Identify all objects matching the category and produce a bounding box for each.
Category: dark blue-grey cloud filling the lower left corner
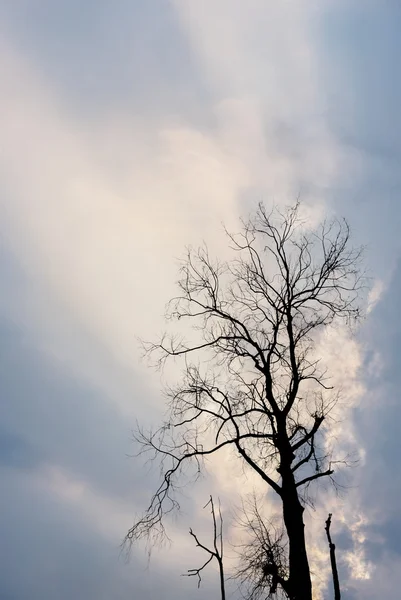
[0,245,214,600]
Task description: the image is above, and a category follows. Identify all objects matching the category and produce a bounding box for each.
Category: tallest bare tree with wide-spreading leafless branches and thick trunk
[126,203,363,600]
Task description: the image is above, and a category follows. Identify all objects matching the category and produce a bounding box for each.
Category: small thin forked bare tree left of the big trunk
[186,496,226,600]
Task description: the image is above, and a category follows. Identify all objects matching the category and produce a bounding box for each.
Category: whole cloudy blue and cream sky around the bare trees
[0,0,401,600]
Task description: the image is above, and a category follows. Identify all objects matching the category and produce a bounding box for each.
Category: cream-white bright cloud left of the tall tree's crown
[0,36,245,390]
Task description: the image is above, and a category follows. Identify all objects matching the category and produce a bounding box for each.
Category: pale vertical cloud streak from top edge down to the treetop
[175,0,351,211]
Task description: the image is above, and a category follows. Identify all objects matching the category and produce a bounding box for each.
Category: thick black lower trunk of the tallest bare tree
[280,422,312,600]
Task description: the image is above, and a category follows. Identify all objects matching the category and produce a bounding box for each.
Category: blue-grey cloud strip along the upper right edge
[318,2,401,276]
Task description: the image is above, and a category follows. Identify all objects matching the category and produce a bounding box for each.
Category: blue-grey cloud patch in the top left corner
[0,0,204,119]
